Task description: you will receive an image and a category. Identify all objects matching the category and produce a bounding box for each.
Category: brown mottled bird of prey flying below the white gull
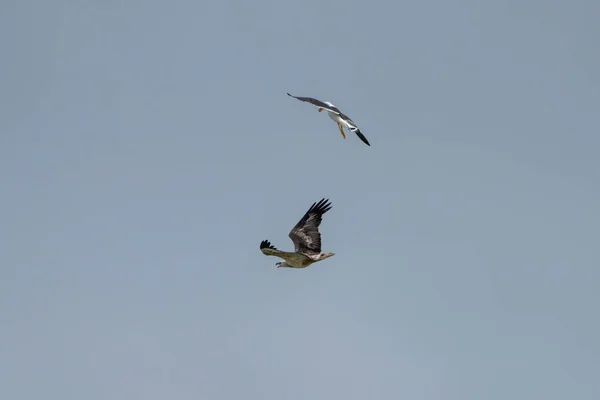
[260,199,335,268]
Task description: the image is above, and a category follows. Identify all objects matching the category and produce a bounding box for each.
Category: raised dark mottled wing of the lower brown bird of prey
[289,199,331,255]
